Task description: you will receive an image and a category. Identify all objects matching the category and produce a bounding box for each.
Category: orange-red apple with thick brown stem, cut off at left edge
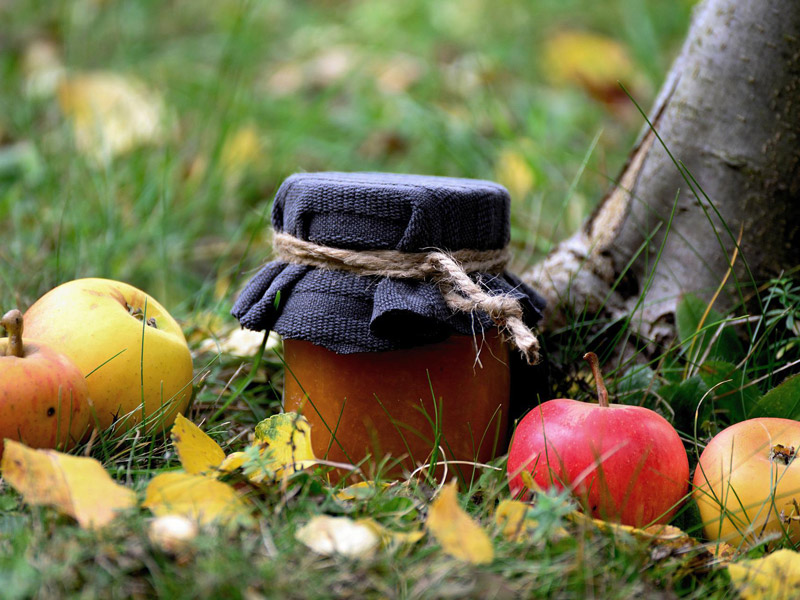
[0,310,91,457]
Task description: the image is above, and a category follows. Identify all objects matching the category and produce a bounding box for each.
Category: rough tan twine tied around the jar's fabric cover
[273,232,540,364]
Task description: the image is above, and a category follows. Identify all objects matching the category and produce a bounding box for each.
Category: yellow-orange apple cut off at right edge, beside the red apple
[692,417,800,545]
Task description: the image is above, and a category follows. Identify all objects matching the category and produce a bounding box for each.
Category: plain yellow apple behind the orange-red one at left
[25,278,192,430]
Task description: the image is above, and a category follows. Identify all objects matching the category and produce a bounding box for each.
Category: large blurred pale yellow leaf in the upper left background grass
[58,72,166,163]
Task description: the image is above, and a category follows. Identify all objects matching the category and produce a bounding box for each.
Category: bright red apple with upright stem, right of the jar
[508,352,689,527]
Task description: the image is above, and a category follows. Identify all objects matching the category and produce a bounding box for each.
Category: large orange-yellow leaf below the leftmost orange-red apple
[0,439,136,528]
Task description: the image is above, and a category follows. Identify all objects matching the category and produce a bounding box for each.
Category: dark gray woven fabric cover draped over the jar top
[232,173,544,354]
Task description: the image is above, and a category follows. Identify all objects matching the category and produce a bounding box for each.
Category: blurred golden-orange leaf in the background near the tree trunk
[543,31,635,102]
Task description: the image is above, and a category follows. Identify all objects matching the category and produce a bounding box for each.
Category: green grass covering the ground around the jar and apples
[0,0,800,600]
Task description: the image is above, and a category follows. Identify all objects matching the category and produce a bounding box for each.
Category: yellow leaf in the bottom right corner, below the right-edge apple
[728,550,800,600]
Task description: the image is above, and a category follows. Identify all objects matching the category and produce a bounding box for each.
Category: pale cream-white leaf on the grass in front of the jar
[295,515,381,558]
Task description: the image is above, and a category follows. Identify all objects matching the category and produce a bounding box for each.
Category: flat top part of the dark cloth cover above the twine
[272,173,510,252]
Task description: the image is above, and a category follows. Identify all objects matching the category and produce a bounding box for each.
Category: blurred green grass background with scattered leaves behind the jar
[0,0,693,319]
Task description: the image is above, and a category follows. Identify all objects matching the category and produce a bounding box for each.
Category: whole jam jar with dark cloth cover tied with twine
[232,173,543,476]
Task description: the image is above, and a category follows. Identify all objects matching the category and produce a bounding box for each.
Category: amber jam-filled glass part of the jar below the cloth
[284,332,510,476]
